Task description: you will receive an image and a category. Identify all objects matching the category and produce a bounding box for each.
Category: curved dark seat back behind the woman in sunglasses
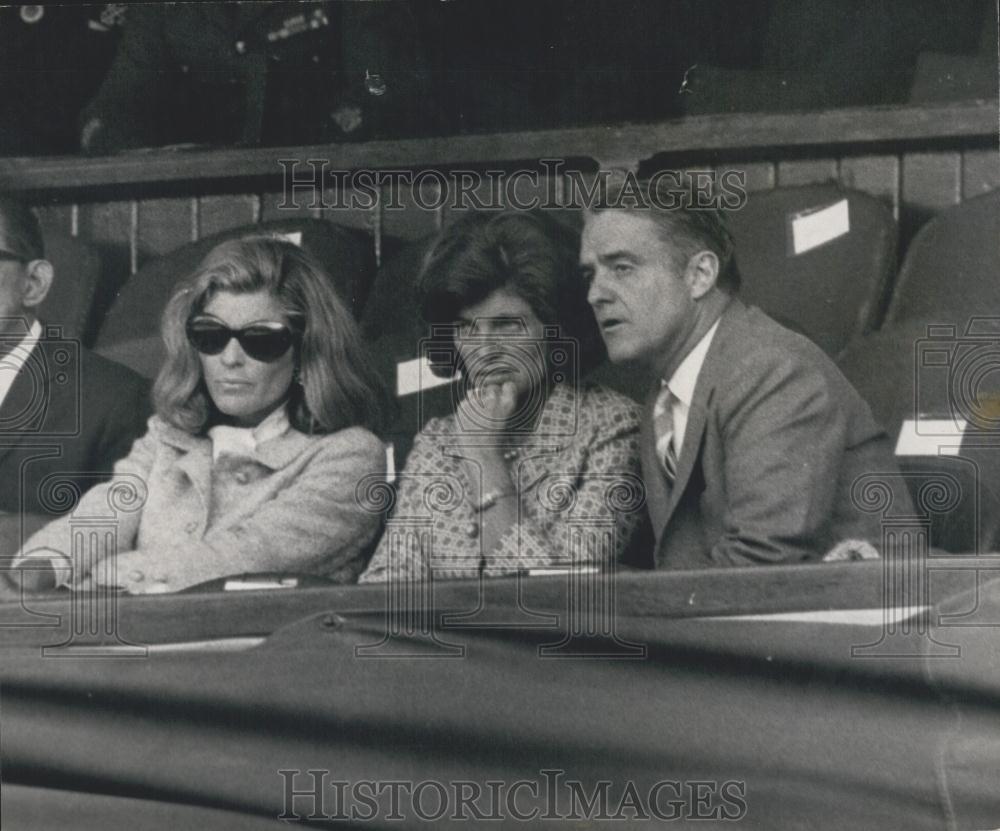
[96,219,375,378]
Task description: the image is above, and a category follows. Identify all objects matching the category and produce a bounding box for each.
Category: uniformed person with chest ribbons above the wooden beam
[80,2,433,153]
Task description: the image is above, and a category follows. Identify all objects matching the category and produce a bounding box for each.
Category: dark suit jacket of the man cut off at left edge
[0,339,150,540]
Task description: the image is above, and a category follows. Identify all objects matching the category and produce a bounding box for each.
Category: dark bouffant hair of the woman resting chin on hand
[419,210,606,375]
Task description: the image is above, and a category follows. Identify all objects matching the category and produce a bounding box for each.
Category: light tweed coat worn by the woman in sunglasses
[22,416,385,592]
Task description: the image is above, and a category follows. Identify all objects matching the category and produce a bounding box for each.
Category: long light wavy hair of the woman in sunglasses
[153,236,389,435]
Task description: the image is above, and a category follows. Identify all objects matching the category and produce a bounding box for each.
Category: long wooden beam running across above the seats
[0,101,1000,192]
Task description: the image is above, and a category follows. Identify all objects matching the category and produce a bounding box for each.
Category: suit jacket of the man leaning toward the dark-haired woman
[640,299,912,568]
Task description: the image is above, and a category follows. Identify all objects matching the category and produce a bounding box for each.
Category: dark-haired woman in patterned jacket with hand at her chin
[361,211,642,582]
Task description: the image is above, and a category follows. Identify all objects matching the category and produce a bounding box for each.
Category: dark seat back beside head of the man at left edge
[39,234,102,345]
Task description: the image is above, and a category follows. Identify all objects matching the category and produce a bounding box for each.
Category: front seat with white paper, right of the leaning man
[839,321,1000,553]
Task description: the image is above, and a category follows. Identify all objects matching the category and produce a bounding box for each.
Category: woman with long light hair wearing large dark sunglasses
[16,238,385,593]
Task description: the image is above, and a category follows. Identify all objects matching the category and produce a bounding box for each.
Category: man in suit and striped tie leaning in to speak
[581,180,909,568]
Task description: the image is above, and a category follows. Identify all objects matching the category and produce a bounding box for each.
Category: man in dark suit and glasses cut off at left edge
[0,198,149,556]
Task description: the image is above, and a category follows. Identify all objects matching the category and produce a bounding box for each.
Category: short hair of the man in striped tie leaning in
[587,170,741,294]
